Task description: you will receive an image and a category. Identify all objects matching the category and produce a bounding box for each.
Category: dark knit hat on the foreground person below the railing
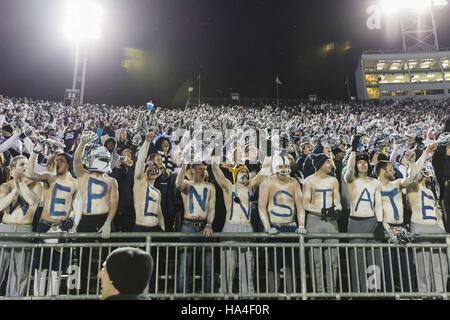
[106,247,153,294]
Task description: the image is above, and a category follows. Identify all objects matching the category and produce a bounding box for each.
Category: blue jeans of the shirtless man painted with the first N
[177,221,212,293]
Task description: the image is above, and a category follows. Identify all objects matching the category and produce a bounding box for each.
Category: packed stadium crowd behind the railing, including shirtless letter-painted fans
[0,96,450,296]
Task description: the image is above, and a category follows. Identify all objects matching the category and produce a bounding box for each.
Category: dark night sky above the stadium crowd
[0,0,450,105]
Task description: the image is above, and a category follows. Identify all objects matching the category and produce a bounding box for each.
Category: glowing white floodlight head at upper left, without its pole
[63,0,103,42]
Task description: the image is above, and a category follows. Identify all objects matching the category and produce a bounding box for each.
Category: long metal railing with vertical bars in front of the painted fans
[0,233,450,300]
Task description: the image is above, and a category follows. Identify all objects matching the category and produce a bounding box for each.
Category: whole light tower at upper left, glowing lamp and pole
[63,0,103,106]
